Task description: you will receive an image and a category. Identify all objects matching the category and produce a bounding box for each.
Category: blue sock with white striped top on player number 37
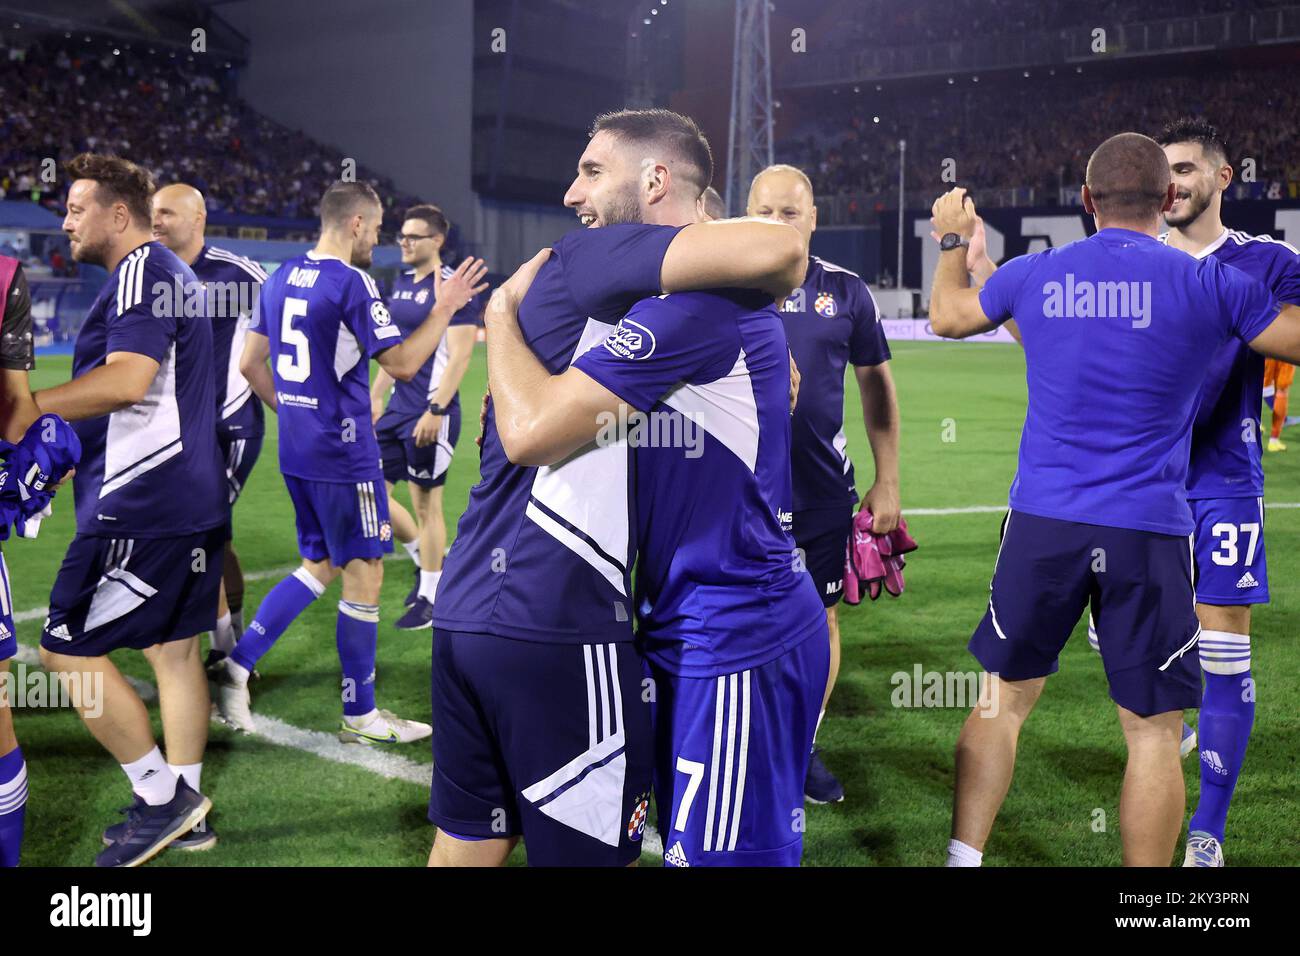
[1187,631,1255,842]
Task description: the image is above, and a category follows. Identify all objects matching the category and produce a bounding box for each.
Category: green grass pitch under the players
[5,343,1300,866]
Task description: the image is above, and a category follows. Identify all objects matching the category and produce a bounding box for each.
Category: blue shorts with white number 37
[1187,498,1269,605]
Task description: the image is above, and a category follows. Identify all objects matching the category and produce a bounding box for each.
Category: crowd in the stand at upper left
[0,31,416,228]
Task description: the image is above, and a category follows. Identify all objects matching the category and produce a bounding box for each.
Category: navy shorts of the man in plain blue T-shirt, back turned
[969,511,1201,717]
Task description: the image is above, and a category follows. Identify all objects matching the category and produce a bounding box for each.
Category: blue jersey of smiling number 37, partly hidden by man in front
[1161,229,1300,498]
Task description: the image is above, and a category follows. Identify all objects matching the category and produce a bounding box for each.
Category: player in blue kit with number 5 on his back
[216,182,486,744]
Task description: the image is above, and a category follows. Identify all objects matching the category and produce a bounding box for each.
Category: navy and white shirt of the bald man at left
[190,246,267,438]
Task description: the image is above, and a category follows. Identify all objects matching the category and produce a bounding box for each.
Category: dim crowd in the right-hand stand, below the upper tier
[776,66,1300,217]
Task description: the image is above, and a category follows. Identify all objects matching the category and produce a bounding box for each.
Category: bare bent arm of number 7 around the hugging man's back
[484,250,621,466]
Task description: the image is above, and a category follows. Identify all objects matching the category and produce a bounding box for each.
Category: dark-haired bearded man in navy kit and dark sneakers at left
[35,153,230,866]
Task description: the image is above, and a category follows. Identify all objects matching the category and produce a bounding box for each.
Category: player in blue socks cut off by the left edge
[0,247,40,866]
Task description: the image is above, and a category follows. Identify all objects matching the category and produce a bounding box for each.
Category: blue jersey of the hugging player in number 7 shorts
[573,293,826,678]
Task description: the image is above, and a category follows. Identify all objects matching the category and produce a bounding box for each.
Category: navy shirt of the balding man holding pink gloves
[781,256,889,511]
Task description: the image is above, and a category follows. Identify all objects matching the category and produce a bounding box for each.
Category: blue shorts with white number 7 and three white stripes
[650,627,831,866]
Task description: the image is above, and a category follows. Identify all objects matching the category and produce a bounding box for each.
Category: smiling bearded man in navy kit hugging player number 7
[429,109,805,866]
